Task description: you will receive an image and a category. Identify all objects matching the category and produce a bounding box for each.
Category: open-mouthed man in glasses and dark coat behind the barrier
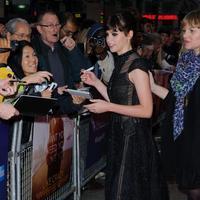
[33,11,89,113]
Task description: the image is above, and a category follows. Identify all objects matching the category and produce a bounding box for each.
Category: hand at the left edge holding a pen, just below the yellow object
[0,78,17,96]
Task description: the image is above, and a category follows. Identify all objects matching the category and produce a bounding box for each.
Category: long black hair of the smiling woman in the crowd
[8,40,33,79]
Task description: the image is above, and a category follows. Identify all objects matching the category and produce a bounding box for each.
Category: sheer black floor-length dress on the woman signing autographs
[105,51,168,200]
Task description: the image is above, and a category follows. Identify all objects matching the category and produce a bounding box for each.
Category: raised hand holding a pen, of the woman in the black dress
[81,70,99,86]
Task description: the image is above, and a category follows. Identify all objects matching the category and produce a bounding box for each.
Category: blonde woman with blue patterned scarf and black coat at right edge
[151,9,200,200]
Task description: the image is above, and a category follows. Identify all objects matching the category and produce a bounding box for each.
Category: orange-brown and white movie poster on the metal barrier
[32,116,75,200]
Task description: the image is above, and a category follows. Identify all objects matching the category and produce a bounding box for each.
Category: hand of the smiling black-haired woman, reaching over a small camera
[22,71,53,84]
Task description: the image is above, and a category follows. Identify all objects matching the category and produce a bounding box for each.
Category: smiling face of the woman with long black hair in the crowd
[22,46,38,76]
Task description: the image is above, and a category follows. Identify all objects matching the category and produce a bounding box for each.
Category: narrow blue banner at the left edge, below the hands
[0,121,9,200]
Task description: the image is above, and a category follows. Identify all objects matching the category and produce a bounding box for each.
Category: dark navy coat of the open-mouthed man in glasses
[32,36,90,114]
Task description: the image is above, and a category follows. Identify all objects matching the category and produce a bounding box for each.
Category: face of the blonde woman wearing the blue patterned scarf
[182,22,200,53]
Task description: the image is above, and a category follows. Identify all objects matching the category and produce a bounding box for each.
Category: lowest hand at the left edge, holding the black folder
[0,103,19,120]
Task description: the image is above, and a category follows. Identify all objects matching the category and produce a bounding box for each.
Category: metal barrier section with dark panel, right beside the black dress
[77,113,108,199]
